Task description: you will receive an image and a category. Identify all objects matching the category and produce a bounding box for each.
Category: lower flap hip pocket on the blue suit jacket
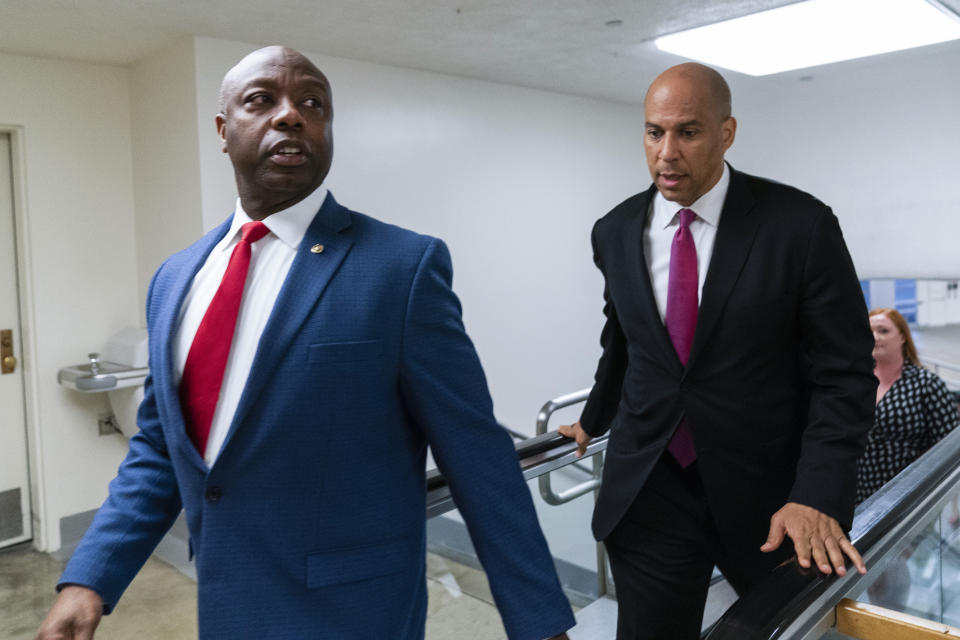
[307,538,419,589]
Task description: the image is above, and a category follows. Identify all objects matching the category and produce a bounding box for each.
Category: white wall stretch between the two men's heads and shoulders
[196,38,649,433]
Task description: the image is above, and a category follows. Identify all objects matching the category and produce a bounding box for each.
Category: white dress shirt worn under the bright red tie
[173,186,327,467]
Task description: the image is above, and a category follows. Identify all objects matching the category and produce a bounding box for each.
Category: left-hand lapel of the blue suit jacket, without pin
[157,215,233,470]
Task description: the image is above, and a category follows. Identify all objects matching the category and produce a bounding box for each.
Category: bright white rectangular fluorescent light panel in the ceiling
[655,0,960,76]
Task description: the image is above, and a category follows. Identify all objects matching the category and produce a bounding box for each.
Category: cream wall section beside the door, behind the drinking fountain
[0,54,137,549]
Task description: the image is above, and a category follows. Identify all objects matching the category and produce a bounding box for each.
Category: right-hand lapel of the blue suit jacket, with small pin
[220,194,354,456]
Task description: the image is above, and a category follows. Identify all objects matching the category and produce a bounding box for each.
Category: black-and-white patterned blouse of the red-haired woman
[857,363,960,504]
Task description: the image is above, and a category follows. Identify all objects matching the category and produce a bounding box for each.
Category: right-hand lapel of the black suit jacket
[687,168,760,369]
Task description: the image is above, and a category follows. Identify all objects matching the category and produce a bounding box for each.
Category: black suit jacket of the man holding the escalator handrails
[581,170,876,547]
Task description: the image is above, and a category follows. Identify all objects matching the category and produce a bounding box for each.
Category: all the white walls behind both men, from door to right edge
[15,31,960,549]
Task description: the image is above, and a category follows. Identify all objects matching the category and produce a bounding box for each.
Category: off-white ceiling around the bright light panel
[0,0,960,103]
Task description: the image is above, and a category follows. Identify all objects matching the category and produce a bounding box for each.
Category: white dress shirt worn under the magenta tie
[643,163,730,319]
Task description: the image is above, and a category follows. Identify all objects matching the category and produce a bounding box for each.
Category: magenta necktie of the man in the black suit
[664,209,699,468]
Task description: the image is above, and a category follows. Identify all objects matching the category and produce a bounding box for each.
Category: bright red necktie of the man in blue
[180,222,270,457]
